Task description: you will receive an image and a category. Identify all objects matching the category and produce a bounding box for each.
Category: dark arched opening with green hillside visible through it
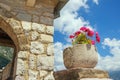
[0,28,16,80]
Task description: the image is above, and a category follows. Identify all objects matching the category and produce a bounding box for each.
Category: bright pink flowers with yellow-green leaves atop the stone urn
[69,27,100,45]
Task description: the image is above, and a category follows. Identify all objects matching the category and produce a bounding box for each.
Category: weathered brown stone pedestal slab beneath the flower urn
[54,68,111,80]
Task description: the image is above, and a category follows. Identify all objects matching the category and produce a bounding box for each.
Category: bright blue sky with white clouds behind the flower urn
[54,0,120,71]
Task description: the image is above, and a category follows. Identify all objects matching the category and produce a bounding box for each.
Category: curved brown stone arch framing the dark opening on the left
[0,16,29,80]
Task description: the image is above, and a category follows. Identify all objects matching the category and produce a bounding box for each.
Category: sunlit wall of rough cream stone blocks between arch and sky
[16,21,54,80]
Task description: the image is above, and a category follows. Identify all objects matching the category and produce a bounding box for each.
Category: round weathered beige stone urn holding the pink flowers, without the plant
[63,44,98,69]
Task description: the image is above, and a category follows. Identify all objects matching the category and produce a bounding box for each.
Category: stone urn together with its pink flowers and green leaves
[63,27,100,69]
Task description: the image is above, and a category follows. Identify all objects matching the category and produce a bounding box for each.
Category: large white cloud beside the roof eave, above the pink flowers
[54,0,96,35]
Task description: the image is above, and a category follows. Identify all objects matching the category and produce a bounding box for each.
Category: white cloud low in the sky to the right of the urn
[96,38,120,71]
